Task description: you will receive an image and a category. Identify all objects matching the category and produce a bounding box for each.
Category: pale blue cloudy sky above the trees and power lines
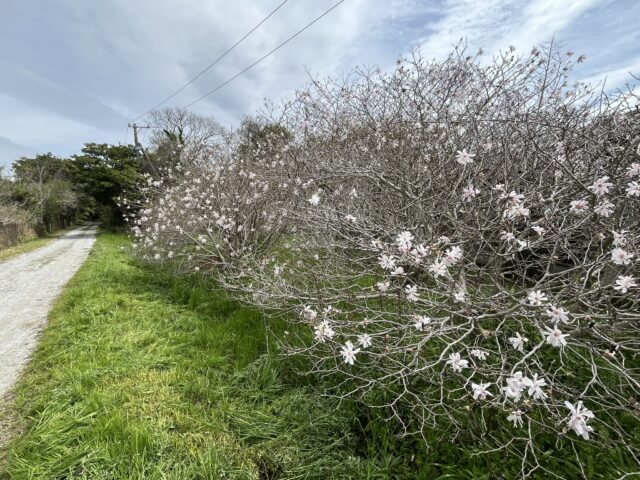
[0,0,640,165]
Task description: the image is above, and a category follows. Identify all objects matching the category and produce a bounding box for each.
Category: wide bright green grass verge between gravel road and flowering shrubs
[0,234,375,480]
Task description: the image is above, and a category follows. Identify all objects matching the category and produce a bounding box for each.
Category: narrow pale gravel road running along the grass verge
[0,226,97,398]
